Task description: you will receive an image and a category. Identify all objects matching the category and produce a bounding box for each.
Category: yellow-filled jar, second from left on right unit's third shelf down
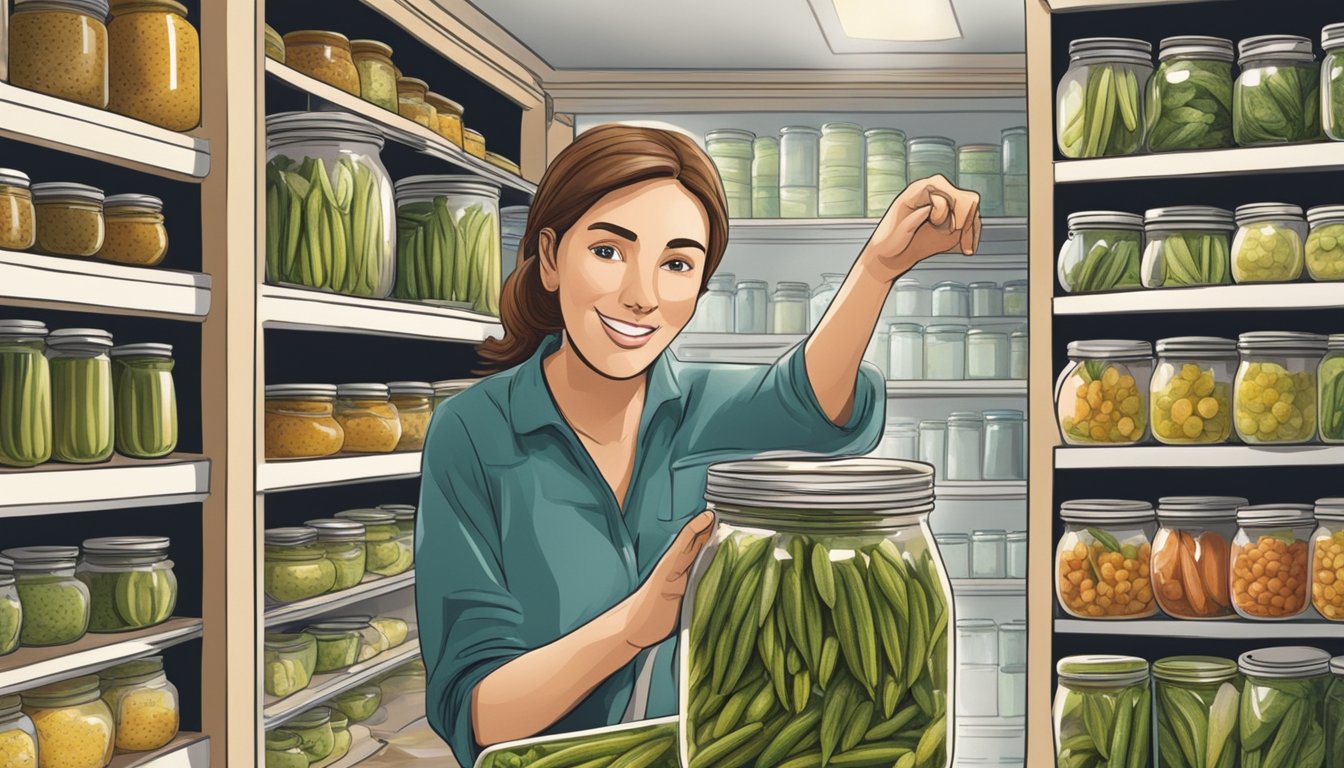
[1149,336,1236,445]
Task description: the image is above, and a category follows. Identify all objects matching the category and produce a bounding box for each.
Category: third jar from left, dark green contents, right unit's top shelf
[1232,35,1325,147]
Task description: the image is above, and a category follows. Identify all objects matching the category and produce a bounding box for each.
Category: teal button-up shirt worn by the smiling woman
[415,336,886,767]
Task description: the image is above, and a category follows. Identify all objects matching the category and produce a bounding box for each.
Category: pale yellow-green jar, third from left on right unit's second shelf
[1232,203,1306,282]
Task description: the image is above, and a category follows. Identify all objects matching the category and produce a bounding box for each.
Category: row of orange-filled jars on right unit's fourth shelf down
[1055,496,1344,621]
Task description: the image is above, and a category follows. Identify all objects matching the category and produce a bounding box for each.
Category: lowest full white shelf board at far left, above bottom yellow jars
[0,619,202,695]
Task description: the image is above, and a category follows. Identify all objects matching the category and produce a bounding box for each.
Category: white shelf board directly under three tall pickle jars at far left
[0,453,210,518]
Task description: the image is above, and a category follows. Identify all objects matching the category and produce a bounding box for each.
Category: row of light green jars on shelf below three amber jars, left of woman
[263,504,415,603]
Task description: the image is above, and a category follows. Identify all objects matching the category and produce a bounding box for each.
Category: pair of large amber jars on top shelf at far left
[9,0,200,130]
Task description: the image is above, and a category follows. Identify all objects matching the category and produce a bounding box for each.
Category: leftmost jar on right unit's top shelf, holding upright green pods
[1055,38,1153,159]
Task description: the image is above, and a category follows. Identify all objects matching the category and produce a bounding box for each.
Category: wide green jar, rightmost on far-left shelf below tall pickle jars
[75,537,177,632]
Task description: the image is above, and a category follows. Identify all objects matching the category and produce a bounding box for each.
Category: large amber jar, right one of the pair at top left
[108,0,200,130]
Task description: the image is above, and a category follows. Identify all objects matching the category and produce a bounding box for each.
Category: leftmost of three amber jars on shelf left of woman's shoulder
[266,385,345,460]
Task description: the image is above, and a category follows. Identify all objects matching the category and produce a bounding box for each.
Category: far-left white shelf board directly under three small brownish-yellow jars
[0,250,210,320]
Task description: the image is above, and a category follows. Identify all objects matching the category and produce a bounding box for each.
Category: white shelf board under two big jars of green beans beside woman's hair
[257,285,504,344]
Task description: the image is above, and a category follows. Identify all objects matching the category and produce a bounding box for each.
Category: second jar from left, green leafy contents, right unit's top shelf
[1145,35,1235,152]
